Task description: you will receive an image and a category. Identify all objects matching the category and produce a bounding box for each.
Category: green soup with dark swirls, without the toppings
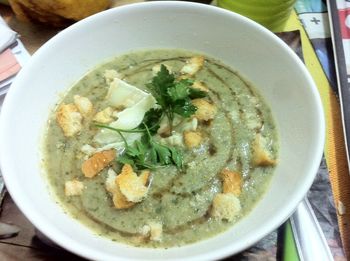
[45,50,278,248]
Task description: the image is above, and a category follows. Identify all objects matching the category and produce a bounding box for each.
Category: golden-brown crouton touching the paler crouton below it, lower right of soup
[220,169,242,196]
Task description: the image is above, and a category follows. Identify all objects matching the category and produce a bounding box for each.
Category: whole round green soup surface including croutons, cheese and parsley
[44,49,278,248]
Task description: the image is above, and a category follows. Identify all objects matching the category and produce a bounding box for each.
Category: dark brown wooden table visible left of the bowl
[0,4,75,260]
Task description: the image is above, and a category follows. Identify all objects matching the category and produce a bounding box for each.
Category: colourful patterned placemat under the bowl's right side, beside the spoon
[232,0,350,260]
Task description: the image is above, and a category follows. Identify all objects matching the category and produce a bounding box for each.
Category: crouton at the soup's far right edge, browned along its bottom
[252,134,277,167]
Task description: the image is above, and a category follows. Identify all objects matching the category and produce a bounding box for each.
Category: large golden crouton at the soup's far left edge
[56,103,83,137]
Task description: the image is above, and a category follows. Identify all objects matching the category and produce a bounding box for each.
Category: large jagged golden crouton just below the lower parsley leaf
[116,164,150,202]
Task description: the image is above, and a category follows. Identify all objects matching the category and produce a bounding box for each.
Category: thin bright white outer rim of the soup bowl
[0,1,325,260]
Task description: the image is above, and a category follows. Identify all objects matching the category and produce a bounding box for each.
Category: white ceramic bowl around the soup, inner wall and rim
[0,2,324,260]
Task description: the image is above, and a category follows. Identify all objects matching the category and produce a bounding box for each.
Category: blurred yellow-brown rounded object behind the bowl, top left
[6,0,110,27]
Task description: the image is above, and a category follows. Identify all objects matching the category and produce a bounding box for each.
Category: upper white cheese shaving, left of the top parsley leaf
[106,78,149,108]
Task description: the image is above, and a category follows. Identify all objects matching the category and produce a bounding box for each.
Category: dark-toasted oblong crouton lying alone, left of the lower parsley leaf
[81,149,116,178]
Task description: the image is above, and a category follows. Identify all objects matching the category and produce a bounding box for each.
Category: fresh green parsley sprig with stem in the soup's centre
[96,64,206,170]
